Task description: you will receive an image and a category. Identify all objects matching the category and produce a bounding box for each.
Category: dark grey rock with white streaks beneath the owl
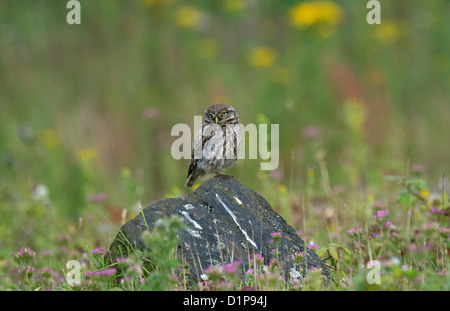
[106,176,331,282]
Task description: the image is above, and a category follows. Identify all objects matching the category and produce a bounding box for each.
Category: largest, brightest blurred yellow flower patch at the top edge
[288,1,343,28]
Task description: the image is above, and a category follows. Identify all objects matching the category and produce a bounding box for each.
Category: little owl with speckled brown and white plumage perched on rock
[185,104,241,188]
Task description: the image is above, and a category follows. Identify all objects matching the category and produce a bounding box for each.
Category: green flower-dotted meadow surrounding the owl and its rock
[0,0,450,290]
